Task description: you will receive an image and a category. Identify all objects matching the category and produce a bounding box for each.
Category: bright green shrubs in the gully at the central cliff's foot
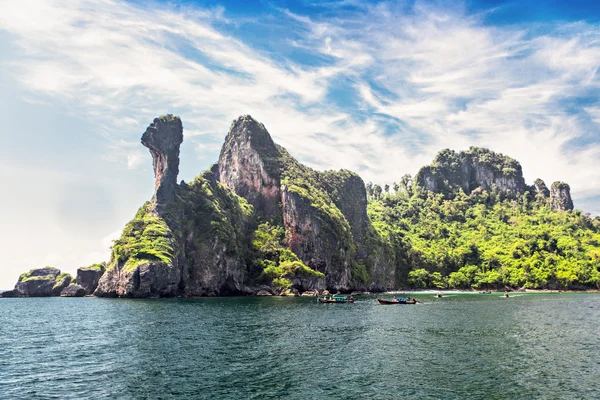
[252,222,324,288]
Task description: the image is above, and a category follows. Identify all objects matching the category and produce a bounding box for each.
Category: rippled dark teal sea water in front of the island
[0,294,600,400]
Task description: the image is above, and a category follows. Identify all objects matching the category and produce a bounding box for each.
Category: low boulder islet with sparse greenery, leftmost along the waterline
[14,267,73,297]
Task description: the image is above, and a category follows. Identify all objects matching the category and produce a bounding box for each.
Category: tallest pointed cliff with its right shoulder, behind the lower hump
[218,116,393,290]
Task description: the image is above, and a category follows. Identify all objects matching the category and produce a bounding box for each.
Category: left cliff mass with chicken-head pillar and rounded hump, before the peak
[94,116,254,297]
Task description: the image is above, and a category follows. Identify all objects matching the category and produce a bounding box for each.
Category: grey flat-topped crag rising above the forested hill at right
[415,147,527,196]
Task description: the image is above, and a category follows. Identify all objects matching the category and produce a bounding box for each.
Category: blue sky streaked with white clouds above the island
[0,0,600,289]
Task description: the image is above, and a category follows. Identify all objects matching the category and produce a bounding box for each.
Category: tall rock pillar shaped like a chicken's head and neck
[142,114,183,213]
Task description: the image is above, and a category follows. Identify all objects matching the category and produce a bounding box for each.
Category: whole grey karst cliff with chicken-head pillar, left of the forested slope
[95,115,396,297]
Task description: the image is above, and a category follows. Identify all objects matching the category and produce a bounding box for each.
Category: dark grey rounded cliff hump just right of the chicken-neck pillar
[169,172,254,296]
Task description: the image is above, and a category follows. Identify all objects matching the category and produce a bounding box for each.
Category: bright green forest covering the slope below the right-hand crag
[368,189,600,289]
